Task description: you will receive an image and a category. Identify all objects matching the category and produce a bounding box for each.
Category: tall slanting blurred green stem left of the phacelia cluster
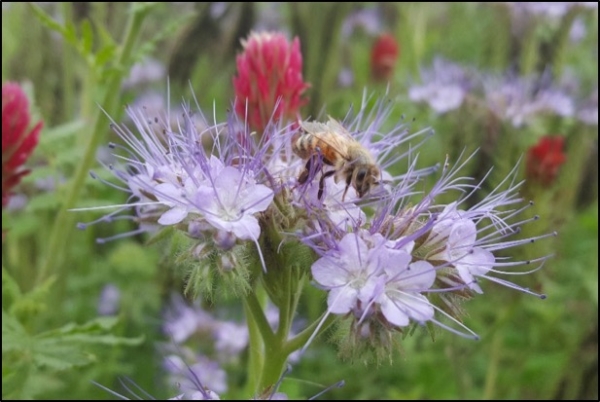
[36,4,150,284]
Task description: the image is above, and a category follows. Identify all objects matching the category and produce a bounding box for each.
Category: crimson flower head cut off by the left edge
[2,82,42,207]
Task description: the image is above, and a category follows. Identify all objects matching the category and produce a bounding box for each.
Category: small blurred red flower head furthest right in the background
[526,135,567,186]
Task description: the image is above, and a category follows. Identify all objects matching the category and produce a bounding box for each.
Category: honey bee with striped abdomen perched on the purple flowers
[292,117,381,202]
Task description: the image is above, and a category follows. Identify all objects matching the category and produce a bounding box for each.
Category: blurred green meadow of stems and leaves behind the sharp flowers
[2,2,598,400]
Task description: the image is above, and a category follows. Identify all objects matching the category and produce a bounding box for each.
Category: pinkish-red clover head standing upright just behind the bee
[233,32,309,131]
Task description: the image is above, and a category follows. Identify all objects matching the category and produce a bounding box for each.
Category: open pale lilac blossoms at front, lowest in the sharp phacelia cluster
[312,231,435,326]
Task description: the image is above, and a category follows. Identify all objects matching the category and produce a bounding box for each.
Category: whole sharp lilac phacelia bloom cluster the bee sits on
[81,90,545,348]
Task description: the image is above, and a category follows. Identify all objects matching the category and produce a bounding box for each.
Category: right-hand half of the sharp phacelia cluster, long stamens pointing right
[302,151,553,338]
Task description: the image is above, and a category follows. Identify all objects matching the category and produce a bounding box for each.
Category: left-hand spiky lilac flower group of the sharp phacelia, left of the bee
[80,103,274,244]
